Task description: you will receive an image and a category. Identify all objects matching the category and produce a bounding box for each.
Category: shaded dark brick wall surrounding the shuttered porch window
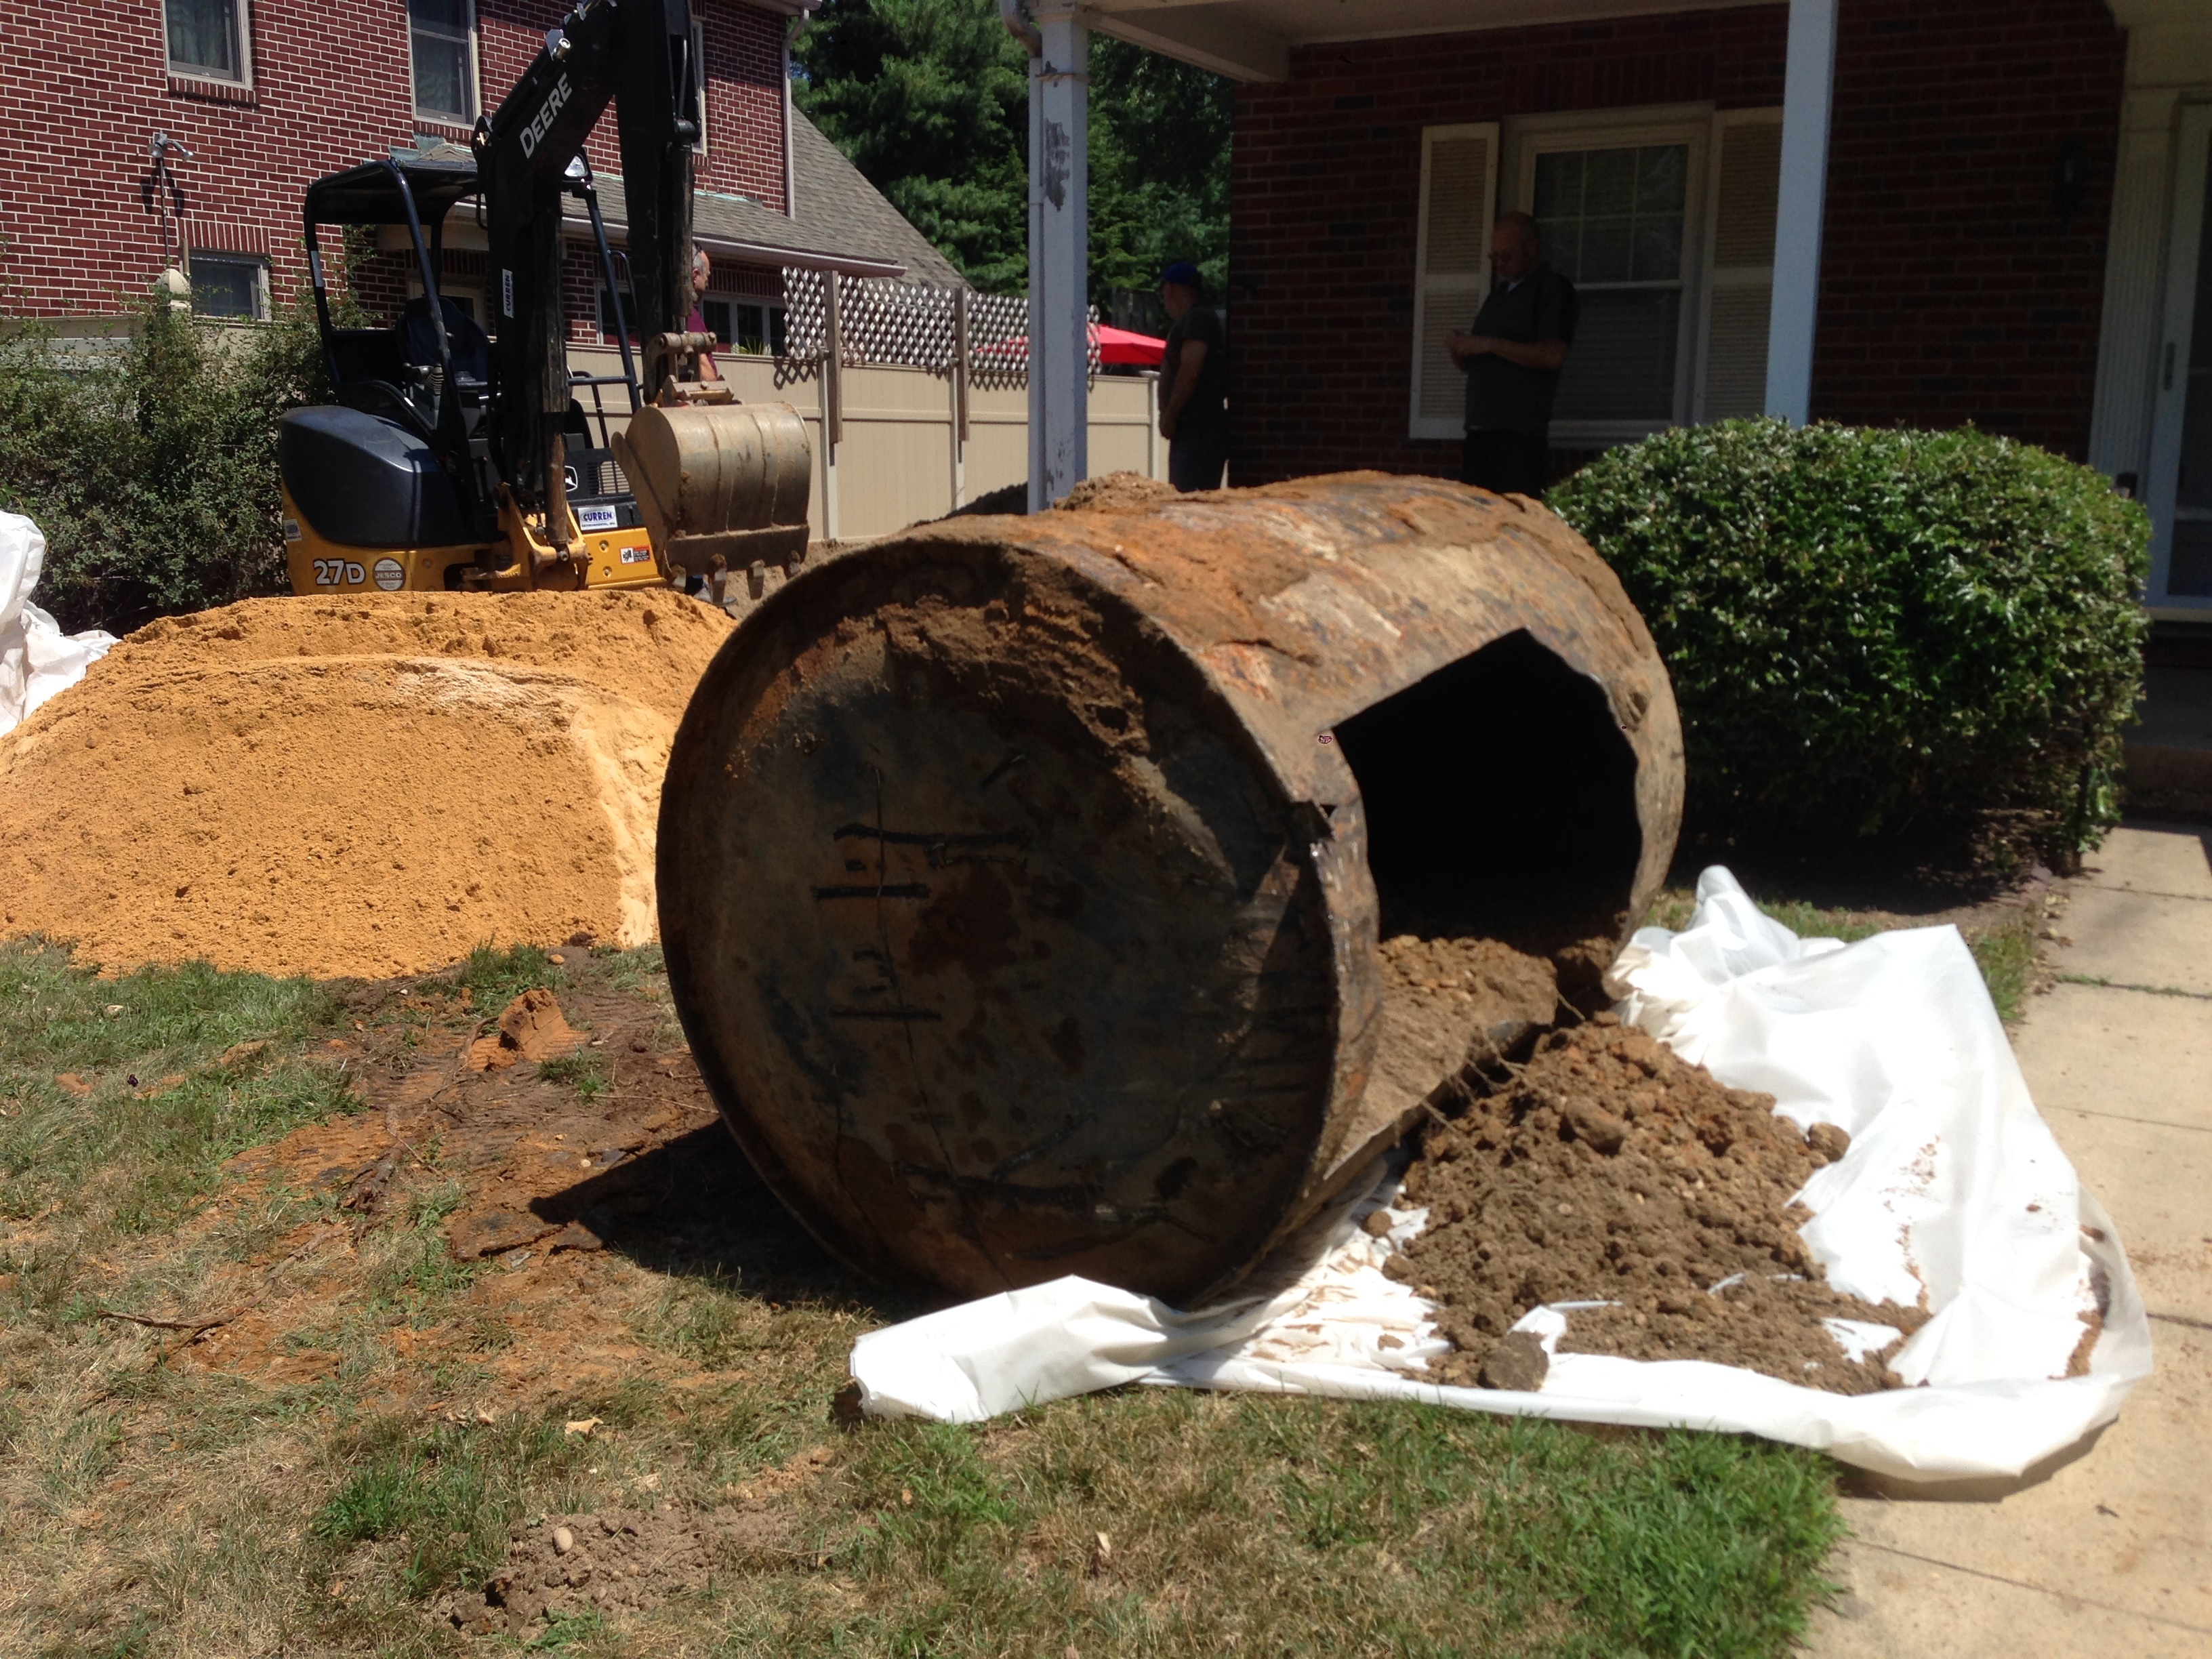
[1230,0,2123,483]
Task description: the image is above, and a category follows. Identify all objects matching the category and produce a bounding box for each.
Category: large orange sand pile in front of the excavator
[0,588,732,978]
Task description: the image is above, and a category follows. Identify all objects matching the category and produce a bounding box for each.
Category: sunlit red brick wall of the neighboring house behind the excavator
[0,0,783,316]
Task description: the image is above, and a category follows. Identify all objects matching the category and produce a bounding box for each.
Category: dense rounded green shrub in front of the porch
[1551,420,2150,861]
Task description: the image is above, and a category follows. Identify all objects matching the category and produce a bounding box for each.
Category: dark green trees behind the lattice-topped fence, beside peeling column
[792,0,1230,305]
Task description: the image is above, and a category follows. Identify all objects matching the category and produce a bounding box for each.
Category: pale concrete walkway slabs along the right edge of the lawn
[1811,823,2212,1659]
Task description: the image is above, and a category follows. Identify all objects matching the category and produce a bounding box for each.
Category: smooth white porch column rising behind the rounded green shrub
[1767,0,1836,427]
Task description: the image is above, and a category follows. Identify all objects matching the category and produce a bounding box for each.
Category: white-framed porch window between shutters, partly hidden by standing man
[1531,144,1690,429]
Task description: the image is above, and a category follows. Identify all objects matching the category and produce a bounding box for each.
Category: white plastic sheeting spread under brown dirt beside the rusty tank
[852,869,2150,1480]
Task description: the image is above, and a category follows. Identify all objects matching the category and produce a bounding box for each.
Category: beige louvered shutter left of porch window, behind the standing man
[1409,122,1498,438]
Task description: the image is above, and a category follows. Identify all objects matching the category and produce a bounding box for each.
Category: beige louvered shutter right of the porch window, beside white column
[1694,108,1783,420]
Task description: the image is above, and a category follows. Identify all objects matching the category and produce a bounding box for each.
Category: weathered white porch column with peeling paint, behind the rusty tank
[1029,0,1090,513]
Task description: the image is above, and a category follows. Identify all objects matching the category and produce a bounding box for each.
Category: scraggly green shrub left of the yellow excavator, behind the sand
[0,290,327,633]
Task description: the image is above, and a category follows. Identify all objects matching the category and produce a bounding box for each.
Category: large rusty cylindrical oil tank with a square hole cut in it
[659,473,1683,1305]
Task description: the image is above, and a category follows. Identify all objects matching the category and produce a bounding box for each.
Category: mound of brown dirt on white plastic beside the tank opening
[1387,1015,1927,1393]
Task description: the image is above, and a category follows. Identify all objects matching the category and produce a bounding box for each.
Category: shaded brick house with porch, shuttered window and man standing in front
[1088,0,2212,619]
